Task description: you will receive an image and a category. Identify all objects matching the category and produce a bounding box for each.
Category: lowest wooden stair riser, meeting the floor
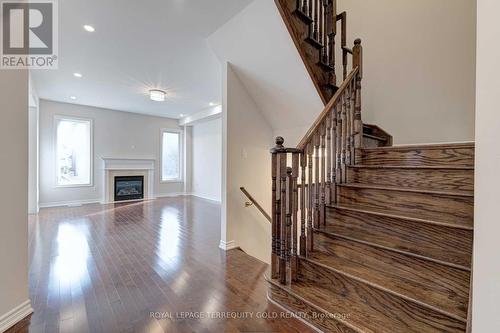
[268,283,359,333]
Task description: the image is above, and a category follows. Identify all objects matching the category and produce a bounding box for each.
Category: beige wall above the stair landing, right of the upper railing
[337,0,476,144]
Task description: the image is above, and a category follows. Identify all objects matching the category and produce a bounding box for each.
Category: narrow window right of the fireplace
[161,130,181,182]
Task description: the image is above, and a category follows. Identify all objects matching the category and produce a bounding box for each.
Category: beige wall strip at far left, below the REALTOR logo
[0,70,31,331]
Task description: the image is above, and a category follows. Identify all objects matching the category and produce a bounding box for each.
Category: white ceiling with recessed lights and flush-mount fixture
[32,0,253,118]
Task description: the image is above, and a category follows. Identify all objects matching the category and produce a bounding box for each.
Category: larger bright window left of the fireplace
[56,117,92,186]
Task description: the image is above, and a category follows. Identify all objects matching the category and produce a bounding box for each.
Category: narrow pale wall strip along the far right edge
[472,0,500,333]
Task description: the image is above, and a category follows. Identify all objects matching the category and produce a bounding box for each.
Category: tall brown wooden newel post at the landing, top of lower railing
[352,38,363,158]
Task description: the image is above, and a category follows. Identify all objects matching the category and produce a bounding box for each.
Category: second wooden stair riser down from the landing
[348,168,474,191]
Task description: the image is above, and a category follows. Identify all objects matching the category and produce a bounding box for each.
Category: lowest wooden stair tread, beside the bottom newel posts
[268,266,465,333]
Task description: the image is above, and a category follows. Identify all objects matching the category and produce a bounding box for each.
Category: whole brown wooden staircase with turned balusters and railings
[266,0,474,333]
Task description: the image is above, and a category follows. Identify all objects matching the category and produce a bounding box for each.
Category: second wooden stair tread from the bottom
[308,233,470,319]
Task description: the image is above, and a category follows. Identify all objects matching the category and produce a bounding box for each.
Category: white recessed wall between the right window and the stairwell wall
[192,118,222,201]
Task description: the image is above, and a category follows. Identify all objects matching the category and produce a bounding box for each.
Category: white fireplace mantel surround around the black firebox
[102,157,156,203]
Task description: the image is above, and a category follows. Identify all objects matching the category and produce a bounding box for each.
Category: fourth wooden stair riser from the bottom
[326,208,472,268]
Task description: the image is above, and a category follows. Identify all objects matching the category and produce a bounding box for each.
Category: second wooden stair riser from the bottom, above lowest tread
[299,260,465,333]
